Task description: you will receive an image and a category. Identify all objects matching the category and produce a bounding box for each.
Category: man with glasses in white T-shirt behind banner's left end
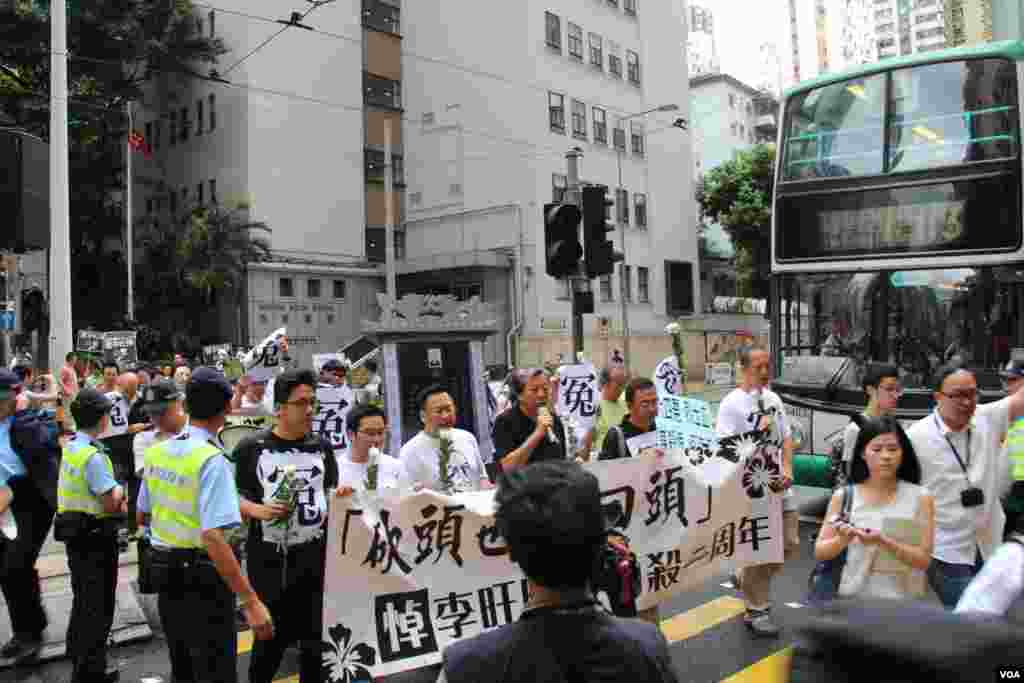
[335,403,406,493]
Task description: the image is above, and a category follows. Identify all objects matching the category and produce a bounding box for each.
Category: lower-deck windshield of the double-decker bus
[775,266,1024,389]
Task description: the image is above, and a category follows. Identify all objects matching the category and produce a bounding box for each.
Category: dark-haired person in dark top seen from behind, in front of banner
[438,461,677,683]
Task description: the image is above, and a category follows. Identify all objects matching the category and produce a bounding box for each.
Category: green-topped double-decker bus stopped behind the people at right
[771,42,1024,464]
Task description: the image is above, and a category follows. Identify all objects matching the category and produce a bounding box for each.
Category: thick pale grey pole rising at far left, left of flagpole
[49,2,73,376]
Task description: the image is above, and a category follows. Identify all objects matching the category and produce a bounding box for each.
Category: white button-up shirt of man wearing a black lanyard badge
[906,398,1010,564]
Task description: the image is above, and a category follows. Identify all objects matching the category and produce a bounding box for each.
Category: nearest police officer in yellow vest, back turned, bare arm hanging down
[137,368,273,683]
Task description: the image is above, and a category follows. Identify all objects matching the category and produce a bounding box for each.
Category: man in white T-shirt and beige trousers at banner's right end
[715,345,800,638]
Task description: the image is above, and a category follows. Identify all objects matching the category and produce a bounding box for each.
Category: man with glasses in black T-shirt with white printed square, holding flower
[234,370,338,683]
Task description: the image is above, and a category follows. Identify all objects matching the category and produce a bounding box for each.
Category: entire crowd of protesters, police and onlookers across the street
[0,346,1024,683]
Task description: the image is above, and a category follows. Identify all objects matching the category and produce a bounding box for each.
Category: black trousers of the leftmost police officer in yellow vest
[67,530,118,683]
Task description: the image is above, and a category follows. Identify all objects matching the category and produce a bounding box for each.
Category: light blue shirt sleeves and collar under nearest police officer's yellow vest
[136,425,242,548]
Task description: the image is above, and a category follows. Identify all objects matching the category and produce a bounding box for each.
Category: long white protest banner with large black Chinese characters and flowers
[323,452,782,681]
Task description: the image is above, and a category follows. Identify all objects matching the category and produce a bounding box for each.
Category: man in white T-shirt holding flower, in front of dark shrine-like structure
[398,384,486,493]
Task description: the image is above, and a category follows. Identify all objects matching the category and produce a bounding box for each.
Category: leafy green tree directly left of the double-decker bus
[696,144,775,299]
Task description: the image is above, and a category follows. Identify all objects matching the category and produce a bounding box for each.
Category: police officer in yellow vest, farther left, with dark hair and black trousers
[53,388,127,683]
